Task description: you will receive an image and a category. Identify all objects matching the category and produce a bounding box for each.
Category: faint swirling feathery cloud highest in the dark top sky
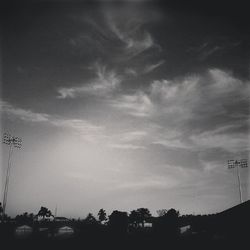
[68,8,161,63]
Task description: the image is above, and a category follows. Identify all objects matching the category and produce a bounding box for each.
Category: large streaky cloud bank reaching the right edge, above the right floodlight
[111,69,250,152]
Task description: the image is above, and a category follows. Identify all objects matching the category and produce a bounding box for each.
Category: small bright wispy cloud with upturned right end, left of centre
[58,63,122,99]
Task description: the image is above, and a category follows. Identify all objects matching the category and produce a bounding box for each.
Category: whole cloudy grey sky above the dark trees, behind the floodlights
[0,1,250,217]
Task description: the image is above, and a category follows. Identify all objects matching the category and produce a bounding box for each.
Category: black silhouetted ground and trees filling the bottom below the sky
[0,202,249,250]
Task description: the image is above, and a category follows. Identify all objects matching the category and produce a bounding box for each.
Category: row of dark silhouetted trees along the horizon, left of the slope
[0,203,217,237]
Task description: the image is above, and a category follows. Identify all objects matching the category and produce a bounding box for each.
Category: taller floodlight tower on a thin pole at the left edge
[3,133,22,218]
